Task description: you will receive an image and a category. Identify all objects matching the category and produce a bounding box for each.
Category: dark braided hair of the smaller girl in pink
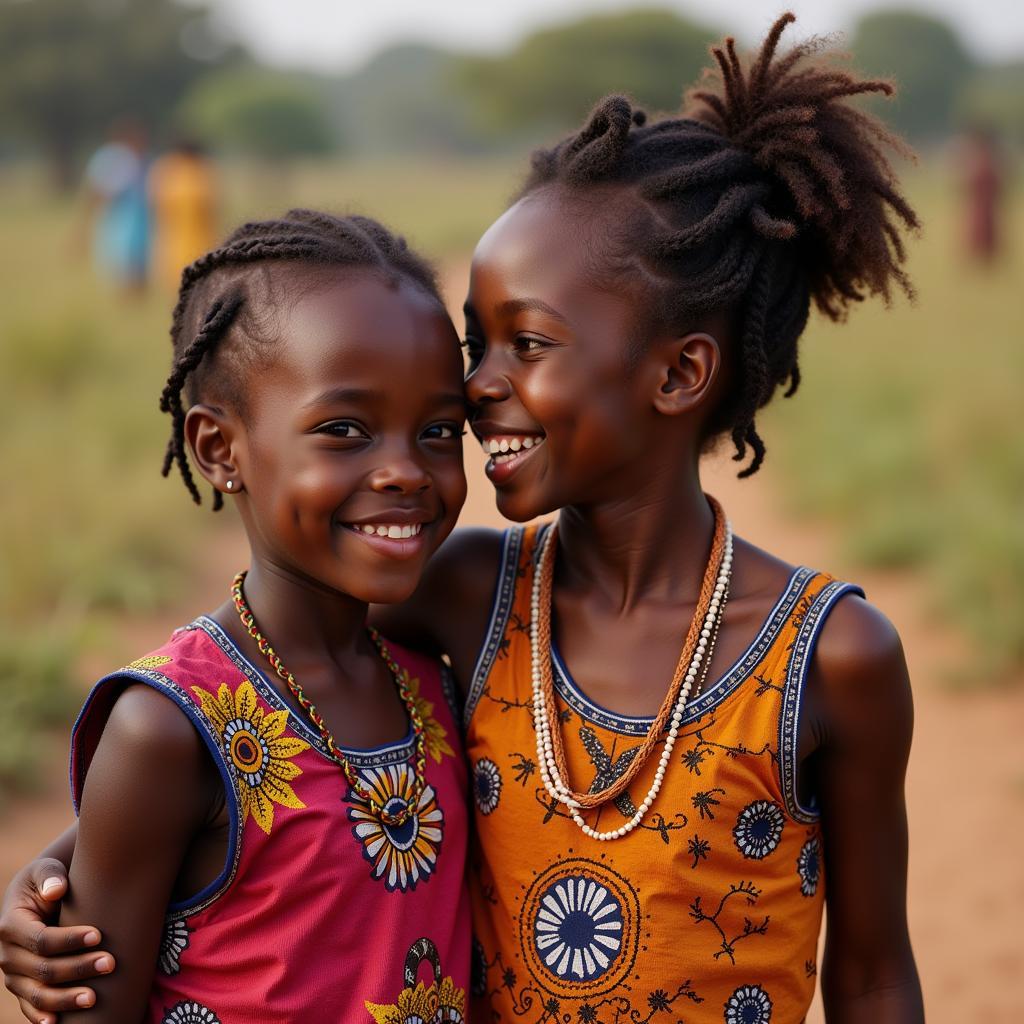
[160,210,443,512]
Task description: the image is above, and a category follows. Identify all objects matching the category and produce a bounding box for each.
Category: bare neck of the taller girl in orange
[556,462,715,613]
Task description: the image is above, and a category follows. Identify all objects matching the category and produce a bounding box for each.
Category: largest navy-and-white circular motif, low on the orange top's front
[534,874,623,981]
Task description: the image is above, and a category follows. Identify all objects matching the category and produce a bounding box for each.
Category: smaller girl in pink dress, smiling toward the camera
[0,210,469,1024]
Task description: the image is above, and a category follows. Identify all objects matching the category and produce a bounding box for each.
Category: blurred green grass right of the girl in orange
[765,167,1024,685]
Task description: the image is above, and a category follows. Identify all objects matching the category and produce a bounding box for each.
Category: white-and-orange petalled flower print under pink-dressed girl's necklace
[347,762,444,892]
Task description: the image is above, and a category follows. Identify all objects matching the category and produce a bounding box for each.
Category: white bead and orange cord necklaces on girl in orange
[530,496,732,841]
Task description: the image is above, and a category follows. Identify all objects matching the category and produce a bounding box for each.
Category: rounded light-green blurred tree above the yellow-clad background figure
[176,67,338,160]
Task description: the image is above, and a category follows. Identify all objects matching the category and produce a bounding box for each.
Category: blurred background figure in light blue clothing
[79,119,151,292]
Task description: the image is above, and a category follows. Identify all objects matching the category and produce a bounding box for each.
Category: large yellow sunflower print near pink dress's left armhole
[193,680,309,836]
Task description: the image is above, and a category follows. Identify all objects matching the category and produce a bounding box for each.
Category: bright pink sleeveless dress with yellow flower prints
[71,617,470,1024]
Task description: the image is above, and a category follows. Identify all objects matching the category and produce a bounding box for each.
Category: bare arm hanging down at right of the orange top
[809,598,925,1024]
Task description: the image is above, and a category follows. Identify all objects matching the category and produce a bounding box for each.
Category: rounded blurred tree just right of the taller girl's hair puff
[852,10,974,140]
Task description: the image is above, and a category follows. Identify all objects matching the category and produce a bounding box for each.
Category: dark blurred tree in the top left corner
[0,0,222,186]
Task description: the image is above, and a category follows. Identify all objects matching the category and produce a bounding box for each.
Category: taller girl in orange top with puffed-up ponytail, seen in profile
[4,15,923,1024]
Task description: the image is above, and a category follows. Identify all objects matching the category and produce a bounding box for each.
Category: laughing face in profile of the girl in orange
[466,191,679,522]
